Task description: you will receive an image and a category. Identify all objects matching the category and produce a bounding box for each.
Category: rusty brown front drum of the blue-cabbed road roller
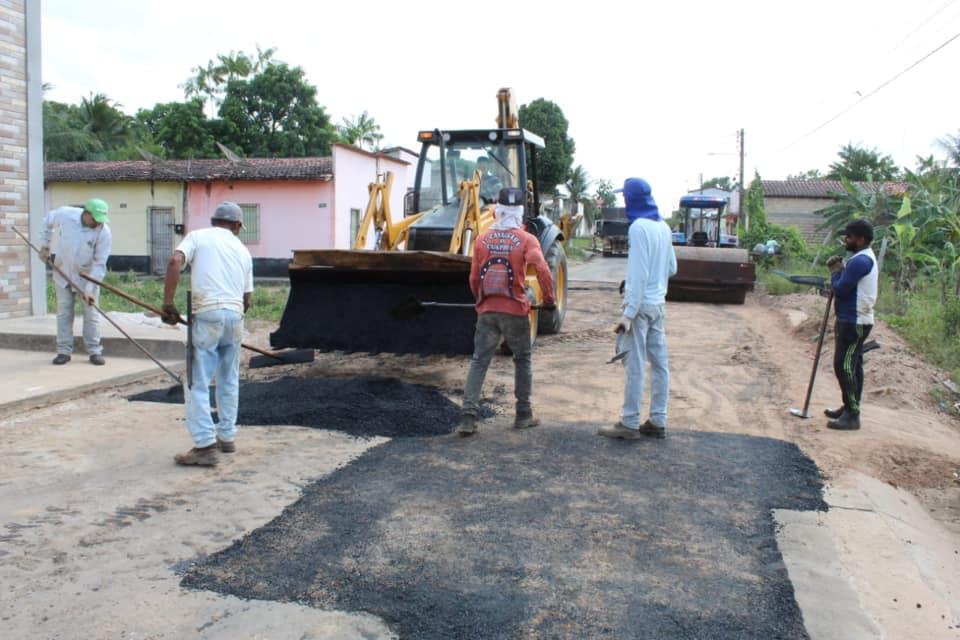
[667,246,756,304]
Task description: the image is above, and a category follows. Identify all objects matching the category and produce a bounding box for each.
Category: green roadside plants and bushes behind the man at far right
[742,134,960,381]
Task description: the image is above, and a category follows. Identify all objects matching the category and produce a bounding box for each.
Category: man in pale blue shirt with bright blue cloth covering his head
[597,178,677,440]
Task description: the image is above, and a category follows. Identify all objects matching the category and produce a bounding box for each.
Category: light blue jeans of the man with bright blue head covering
[620,305,670,429]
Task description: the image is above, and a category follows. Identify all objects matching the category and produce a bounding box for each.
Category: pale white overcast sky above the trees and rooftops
[42,0,960,211]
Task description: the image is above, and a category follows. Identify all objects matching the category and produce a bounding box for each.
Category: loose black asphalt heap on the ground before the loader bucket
[128,377,460,438]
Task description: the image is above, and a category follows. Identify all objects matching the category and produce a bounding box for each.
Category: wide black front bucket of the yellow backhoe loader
[270,251,477,355]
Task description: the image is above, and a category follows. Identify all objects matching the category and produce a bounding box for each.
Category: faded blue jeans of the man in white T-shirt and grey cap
[184,309,243,448]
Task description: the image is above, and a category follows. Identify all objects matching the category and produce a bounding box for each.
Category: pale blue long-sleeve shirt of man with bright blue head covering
[623,218,677,318]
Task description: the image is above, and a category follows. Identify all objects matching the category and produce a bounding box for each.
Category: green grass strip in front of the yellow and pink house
[47,271,290,322]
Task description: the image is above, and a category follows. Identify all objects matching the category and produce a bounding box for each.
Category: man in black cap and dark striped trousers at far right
[824,220,879,431]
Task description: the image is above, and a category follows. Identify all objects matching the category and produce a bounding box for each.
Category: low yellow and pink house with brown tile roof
[45,144,416,277]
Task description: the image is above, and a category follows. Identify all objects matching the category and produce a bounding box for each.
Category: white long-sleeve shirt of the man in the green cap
[43,207,113,295]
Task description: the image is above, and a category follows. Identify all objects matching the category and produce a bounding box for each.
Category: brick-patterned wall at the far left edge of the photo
[0,0,31,318]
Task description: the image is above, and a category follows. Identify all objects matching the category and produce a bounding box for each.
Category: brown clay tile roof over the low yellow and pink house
[44,157,333,182]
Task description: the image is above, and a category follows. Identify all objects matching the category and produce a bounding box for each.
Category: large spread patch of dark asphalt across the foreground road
[183,423,826,640]
